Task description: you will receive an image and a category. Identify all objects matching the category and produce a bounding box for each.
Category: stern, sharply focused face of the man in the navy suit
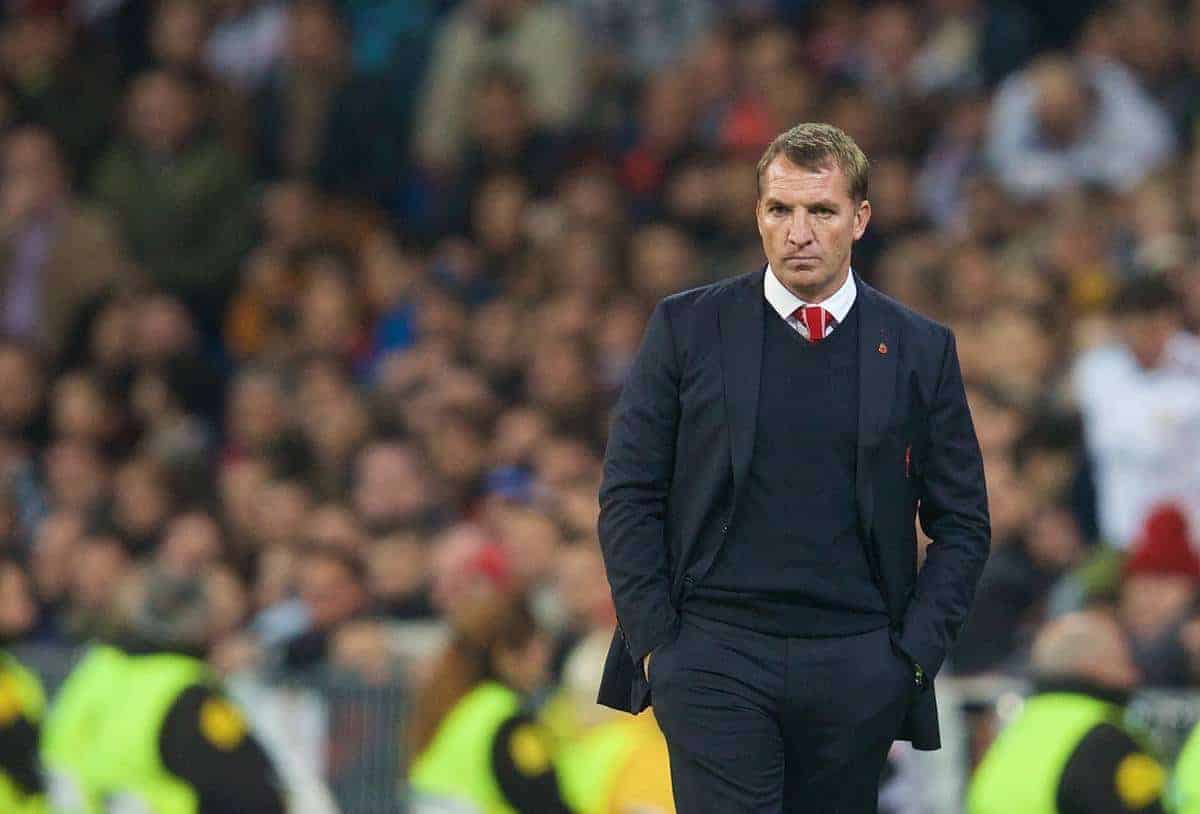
[757,155,871,303]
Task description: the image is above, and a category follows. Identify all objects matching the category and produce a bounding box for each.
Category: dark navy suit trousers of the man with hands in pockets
[649,609,916,814]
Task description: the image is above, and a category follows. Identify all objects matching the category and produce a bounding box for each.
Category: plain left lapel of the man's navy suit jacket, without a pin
[718,268,766,496]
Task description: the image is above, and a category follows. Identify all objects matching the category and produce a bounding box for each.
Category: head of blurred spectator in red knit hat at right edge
[1118,503,1200,684]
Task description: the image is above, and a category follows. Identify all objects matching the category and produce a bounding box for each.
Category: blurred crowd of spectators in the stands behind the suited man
[0,0,1200,814]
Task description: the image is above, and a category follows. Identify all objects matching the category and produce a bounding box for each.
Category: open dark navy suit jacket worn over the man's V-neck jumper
[599,269,991,749]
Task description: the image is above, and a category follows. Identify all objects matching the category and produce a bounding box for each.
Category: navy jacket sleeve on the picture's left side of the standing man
[599,301,679,670]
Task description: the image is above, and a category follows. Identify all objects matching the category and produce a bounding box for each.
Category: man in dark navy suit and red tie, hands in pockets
[599,124,990,814]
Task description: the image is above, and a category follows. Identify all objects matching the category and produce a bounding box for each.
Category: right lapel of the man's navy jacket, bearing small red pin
[854,274,900,534]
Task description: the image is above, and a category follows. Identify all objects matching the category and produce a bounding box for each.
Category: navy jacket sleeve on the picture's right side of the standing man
[900,331,991,678]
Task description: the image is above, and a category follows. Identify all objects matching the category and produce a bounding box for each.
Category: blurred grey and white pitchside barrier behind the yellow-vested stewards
[16,643,1200,814]
